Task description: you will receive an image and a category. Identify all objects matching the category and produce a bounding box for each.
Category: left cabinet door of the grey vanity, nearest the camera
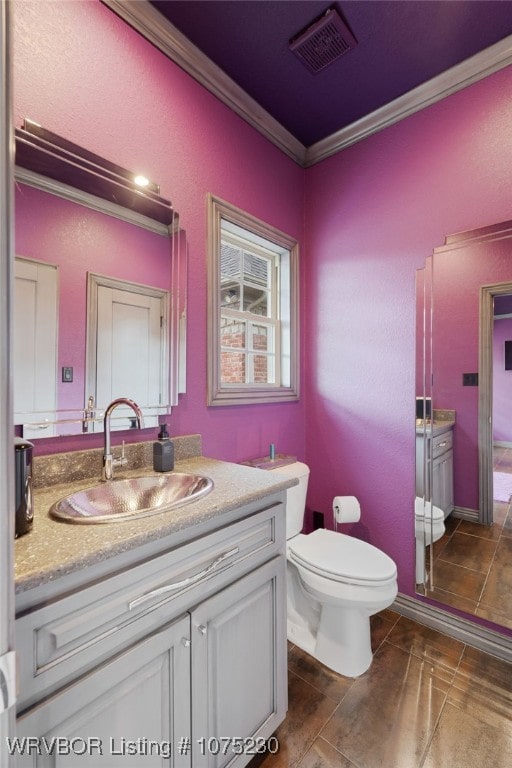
[16,615,191,768]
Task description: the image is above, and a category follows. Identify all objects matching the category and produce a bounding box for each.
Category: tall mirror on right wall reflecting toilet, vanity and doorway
[415,222,512,628]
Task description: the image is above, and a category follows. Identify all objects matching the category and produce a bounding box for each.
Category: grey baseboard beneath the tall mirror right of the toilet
[392,594,512,662]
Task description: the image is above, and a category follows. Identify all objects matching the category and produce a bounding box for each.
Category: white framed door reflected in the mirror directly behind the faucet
[92,285,167,429]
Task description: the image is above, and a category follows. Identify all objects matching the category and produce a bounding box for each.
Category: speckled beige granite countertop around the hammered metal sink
[15,456,294,593]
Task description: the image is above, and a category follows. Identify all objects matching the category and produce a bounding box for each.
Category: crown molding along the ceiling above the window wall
[101,0,306,166]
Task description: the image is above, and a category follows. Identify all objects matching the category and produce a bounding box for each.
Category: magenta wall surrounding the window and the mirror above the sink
[13,0,304,461]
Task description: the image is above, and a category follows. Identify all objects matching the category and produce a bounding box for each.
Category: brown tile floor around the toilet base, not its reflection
[250,610,512,768]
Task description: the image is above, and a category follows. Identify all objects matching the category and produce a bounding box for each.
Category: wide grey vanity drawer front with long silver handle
[16,504,285,706]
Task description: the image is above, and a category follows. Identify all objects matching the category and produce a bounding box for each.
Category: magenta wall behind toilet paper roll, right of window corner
[305,61,512,612]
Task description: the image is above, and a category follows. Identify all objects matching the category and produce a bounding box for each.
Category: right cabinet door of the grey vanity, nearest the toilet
[191,557,287,768]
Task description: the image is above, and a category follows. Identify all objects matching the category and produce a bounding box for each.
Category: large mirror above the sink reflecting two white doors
[14,121,187,439]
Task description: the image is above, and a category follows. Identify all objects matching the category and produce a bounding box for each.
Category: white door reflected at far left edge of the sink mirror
[13,258,58,439]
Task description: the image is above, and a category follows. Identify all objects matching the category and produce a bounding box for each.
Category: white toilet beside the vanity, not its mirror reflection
[273,462,398,677]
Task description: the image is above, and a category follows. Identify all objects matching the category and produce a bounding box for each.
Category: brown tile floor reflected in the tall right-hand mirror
[426,448,512,632]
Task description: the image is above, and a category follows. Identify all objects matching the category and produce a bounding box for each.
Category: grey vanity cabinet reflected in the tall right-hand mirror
[416,426,454,518]
